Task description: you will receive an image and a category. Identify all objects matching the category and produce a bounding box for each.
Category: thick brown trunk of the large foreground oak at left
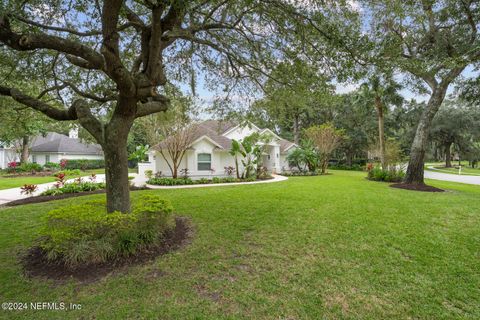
[102,119,133,213]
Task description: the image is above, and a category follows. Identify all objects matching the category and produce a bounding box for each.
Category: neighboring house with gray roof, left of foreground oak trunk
[30,132,103,165]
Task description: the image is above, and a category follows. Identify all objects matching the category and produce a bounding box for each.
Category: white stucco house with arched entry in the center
[139,120,296,178]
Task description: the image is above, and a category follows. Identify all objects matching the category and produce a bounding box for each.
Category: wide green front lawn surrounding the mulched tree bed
[0,171,480,319]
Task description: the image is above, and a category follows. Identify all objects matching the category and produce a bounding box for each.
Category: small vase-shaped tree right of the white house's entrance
[305,123,345,174]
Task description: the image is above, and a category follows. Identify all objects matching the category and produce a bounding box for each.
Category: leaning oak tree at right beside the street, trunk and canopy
[364,0,480,184]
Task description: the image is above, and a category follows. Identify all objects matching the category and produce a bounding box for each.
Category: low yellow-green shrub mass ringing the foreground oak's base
[39,195,174,267]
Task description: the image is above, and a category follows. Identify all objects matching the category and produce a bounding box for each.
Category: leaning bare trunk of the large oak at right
[404,86,447,184]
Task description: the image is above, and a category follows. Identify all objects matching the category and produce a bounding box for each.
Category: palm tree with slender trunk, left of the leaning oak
[359,75,403,170]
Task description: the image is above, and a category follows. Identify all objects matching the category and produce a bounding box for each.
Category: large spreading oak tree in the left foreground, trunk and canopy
[0,0,322,212]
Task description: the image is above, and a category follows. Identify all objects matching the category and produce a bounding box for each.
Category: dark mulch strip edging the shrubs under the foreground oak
[20,217,193,283]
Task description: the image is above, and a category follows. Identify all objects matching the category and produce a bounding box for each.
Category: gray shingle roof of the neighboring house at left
[31,132,103,155]
